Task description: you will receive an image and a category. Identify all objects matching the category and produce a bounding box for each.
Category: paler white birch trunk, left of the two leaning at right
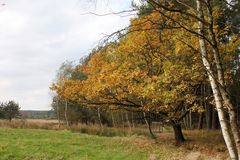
[196,0,238,160]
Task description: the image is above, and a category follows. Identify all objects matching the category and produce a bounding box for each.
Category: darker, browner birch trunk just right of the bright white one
[204,2,240,155]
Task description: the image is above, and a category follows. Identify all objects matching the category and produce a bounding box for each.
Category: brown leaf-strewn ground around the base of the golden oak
[111,130,228,160]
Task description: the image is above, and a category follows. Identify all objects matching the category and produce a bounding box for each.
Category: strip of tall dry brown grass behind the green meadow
[0,119,148,137]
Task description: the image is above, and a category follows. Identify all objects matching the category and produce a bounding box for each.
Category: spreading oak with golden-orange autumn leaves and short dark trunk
[51,13,205,143]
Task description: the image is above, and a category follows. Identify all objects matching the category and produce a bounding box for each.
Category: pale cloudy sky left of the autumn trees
[0,0,136,110]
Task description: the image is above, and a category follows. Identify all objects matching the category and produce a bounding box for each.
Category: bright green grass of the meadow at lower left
[0,128,148,160]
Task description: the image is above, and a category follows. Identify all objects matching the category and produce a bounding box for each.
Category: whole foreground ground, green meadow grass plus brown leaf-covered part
[0,128,228,160]
